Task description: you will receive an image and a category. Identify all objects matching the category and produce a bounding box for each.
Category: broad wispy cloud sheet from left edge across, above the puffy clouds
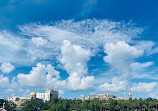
[0,19,142,65]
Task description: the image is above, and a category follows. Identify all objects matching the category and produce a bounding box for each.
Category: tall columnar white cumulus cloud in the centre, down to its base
[60,40,94,90]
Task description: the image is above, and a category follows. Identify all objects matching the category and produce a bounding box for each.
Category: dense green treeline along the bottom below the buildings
[21,98,158,111]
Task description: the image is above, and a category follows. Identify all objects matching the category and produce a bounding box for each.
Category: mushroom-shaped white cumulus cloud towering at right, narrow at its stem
[98,41,143,92]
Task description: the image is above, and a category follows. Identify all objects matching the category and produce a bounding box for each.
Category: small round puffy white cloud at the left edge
[0,62,15,73]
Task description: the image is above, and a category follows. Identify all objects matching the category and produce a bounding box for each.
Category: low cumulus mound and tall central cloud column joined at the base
[17,40,94,90]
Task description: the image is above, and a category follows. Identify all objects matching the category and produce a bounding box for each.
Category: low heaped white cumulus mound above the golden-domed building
[17,63,65,89]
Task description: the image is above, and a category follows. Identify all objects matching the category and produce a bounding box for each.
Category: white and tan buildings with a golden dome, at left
[8,89,58,106]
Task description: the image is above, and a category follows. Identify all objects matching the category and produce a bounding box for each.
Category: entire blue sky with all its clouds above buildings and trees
[0,0,158,99]
